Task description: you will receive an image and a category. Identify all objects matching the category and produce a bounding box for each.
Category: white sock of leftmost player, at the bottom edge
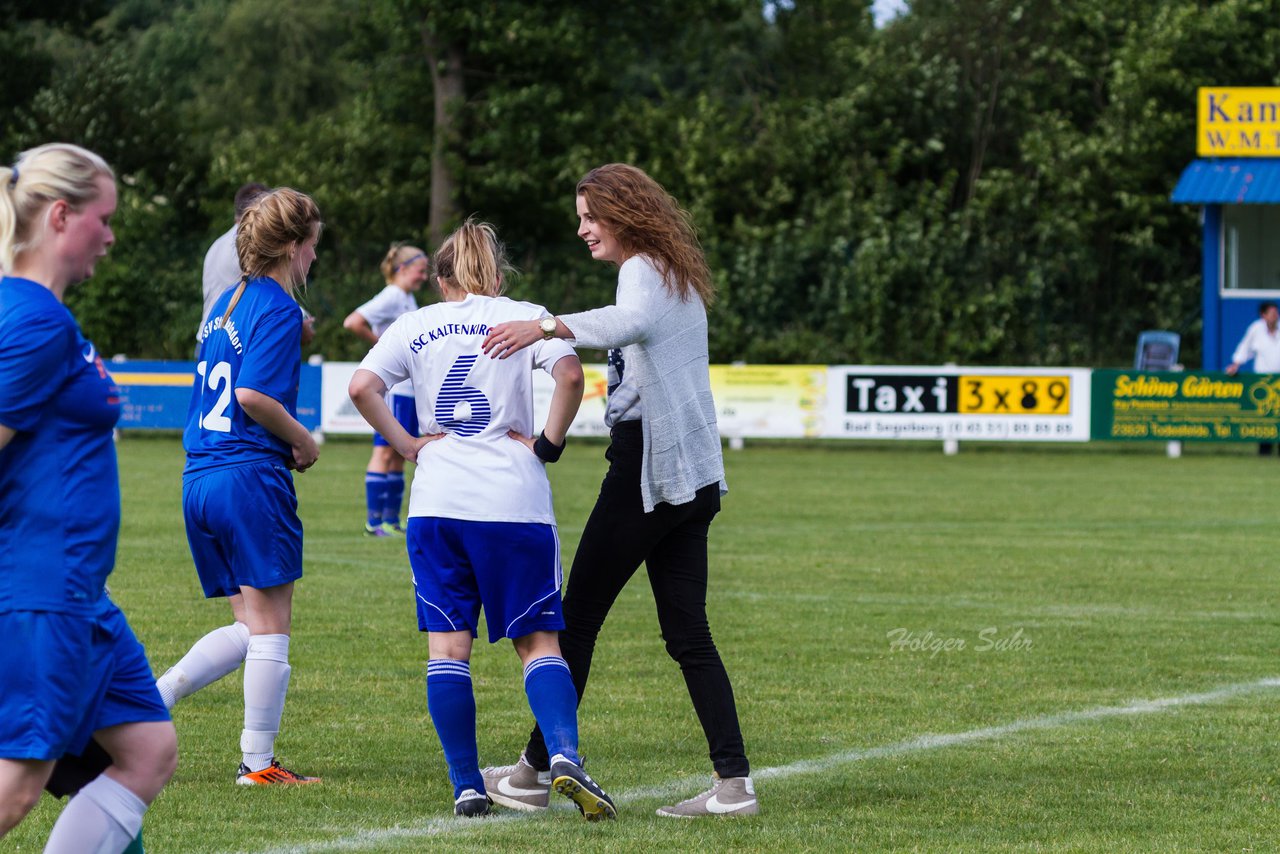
[45,773,147,854]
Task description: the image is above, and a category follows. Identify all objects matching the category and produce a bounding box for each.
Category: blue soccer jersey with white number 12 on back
[182,277,302,478]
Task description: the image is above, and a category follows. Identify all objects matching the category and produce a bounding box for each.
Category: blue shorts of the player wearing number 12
[182,462,302,599]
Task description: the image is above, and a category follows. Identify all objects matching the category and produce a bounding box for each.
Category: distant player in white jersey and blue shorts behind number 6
[342,243,426,536]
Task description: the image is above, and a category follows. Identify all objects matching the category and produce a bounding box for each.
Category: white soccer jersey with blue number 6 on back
[360,294,573,525]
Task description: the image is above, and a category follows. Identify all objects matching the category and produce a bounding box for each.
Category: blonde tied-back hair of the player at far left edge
[0,142,115,270]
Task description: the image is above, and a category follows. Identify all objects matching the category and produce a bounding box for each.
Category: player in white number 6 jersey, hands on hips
[348,220,616,819]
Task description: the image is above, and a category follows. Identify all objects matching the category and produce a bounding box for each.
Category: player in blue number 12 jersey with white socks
[157,188,321,785]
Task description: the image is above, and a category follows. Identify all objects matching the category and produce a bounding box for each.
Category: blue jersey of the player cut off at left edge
[0,278,120,615]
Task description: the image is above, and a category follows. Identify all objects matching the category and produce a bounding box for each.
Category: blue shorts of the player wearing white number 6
[407,516,564,643]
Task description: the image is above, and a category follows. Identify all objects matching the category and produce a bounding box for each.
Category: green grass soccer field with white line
[10,435,1280,854]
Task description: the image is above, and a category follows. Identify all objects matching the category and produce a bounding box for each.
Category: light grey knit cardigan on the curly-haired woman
[561,255,728,513]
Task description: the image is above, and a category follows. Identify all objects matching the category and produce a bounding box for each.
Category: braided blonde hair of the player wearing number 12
[223,187,324,323]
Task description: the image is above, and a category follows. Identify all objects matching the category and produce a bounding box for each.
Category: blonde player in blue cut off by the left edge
[0,143,178,854]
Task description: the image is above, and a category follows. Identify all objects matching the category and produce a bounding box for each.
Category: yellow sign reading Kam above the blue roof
[1196,86,1280,157]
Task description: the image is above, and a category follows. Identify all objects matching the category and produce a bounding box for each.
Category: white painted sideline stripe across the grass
[241,676,1280,854]
